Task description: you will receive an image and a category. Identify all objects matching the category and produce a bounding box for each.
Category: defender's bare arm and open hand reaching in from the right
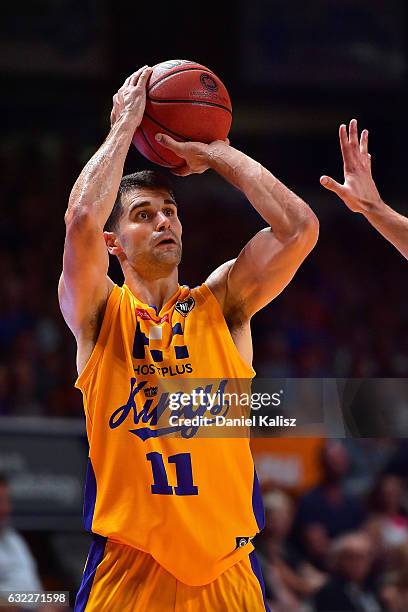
[320,119,408,259]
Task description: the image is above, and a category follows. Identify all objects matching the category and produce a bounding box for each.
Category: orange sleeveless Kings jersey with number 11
[76,284,264,586]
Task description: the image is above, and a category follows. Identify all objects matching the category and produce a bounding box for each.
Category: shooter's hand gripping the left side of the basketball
[110,66,153,130]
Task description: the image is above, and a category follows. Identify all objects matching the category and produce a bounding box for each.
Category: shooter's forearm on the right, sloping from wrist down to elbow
[209,143,318,241]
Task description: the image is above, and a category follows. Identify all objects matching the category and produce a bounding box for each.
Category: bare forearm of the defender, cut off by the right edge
[362,200,408,259]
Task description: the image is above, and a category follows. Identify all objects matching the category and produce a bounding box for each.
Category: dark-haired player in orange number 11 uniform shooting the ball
[59,67,318,612]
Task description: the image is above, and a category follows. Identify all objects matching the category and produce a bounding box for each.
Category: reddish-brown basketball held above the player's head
[133,60,232,168]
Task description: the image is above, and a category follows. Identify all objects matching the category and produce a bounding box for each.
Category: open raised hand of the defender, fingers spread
[320,119,381,213]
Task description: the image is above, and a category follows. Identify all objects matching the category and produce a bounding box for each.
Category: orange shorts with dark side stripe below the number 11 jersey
[74,536,269,612]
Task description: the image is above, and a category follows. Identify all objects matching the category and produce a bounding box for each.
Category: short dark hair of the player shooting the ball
[105,170,175,232]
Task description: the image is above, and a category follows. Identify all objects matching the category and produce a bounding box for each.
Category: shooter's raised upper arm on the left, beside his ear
[58,212,113,338]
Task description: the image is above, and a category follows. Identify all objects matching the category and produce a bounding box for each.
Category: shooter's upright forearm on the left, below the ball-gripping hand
[66,116,135,228]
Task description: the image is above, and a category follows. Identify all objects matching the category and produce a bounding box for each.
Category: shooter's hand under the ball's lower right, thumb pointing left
[156,134,229,176]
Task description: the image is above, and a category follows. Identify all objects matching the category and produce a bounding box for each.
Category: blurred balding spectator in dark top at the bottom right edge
[314,532,381,612]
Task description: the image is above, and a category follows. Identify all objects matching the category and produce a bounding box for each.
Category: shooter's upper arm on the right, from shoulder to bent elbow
[223,222,318,320]
